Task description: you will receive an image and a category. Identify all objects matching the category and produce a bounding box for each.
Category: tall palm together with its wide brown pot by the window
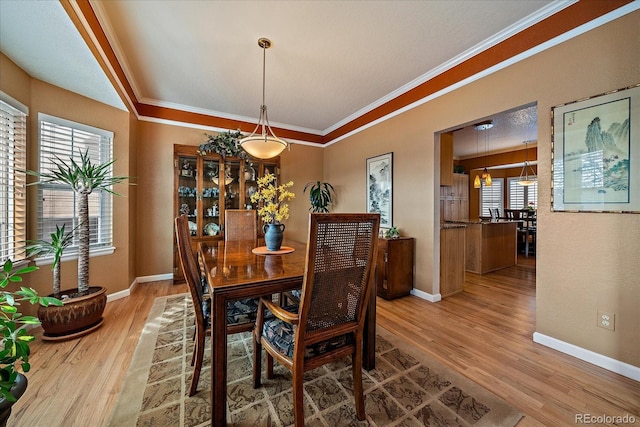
[26,150,129,340]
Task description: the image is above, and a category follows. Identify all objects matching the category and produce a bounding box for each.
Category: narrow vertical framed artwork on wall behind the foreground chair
[367,153,393,228]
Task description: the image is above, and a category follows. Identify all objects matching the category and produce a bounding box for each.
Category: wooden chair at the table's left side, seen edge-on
[175,215,258,396]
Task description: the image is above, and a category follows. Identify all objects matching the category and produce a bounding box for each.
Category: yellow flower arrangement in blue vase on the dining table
[251,173,296,251]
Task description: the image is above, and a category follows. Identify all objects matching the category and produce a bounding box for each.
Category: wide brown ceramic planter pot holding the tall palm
[38,286,107,340]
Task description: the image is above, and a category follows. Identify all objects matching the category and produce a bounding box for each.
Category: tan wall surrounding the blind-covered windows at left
[0,55,135,300]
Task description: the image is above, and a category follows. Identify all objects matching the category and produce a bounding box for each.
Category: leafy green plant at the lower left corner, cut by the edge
[0,259,62,427]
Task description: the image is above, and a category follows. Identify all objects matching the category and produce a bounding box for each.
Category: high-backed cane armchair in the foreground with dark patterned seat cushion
[253,213,380,427]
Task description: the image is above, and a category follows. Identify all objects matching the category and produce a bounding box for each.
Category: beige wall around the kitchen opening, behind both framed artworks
[324,12,640,366]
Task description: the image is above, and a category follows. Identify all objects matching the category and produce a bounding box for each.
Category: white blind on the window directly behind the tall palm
[38,114,113,254]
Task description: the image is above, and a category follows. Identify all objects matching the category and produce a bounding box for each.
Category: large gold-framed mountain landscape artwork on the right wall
[551,84,640,213]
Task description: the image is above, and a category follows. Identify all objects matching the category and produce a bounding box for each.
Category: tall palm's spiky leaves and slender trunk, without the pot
[26,150,129,295]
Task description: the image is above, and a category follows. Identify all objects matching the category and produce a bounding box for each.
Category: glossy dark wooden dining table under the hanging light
[198,240,376,426]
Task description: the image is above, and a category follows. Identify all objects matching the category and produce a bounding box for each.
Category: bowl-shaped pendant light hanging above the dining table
[240,37,288,159]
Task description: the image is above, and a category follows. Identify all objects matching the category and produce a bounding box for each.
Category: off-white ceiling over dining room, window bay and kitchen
[0,0,574,157]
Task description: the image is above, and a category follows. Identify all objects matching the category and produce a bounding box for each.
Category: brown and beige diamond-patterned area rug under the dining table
[108,294,522,427]
